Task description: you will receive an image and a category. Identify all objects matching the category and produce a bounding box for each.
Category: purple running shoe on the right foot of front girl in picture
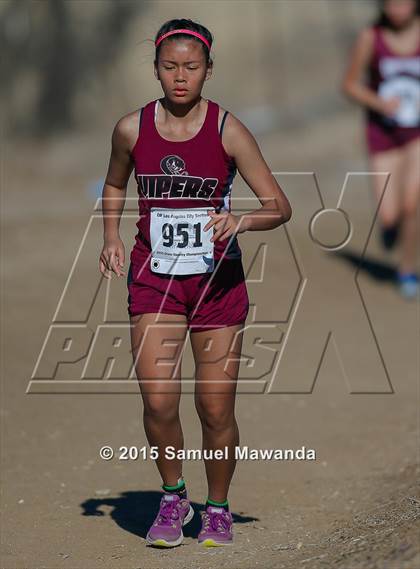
[198,506,233,547]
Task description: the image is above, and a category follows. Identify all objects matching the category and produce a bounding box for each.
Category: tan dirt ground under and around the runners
[1,107,420,569]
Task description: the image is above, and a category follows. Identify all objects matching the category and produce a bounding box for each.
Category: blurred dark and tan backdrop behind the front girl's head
[0,0,376,137]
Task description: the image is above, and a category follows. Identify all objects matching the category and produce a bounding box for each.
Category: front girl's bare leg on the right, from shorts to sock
[191,325,243,502]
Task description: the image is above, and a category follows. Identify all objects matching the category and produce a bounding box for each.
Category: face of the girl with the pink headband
[154,39,212,103]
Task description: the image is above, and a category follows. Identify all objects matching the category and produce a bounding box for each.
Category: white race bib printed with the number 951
[150,207,214,275]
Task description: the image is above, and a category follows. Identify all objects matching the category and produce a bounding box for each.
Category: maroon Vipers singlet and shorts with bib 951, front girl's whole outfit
[127,96,249,331]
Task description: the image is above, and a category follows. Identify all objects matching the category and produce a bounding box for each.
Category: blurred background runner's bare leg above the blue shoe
[399,138,420,273]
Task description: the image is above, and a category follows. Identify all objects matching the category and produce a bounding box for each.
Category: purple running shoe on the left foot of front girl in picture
[146,492,194,547]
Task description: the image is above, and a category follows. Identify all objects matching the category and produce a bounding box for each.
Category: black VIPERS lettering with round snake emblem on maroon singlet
[137,154,219,200]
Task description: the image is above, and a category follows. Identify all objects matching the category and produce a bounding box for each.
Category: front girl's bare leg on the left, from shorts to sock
[130,313,187,486]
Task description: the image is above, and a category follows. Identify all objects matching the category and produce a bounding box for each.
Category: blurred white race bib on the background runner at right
[378,75,420,127]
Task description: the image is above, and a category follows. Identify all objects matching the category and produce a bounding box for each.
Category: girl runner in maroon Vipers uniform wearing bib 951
[99,19,291,547]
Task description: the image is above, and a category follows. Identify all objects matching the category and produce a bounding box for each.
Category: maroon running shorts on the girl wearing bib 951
[127,254,249,332]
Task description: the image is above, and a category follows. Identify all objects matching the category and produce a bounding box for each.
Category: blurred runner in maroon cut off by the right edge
[343,0,420,298]
